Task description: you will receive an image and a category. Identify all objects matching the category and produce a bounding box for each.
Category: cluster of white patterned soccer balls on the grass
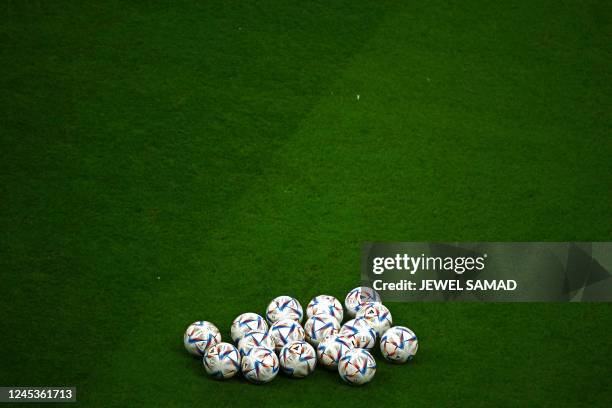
[183,287,418,385]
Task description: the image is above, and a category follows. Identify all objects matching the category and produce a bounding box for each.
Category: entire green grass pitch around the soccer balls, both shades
[0,0,612,407]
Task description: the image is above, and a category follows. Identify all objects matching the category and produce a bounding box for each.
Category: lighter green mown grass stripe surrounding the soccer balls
[85,4,610,405]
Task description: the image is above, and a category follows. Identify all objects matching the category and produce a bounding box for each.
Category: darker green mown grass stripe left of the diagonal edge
[0,2,392,392]
